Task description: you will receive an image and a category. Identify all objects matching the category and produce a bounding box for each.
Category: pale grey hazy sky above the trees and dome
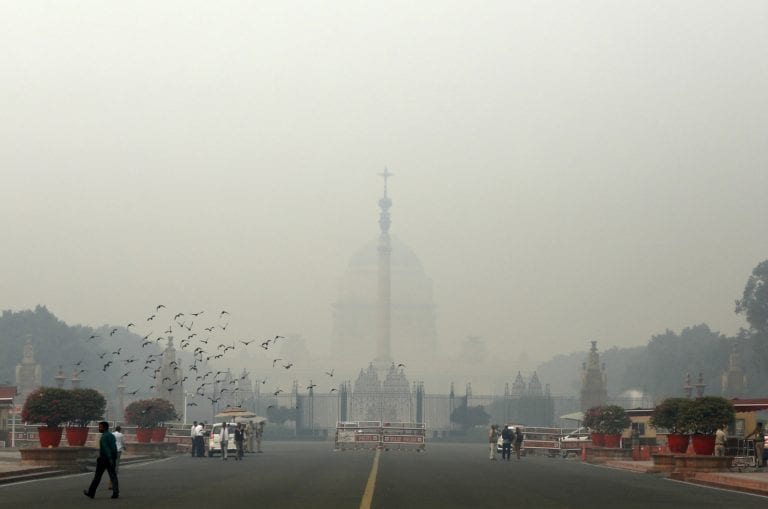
[0,0,768,359]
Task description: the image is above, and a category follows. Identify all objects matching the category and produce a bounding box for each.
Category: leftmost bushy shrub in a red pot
[21,387,71,447]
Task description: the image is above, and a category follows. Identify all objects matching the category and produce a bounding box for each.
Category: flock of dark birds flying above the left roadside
[74,304,352,406]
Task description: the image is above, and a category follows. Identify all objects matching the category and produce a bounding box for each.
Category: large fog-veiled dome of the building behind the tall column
[332,236,437,365]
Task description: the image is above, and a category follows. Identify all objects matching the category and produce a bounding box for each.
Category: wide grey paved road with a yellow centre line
[0,442,768,509]
